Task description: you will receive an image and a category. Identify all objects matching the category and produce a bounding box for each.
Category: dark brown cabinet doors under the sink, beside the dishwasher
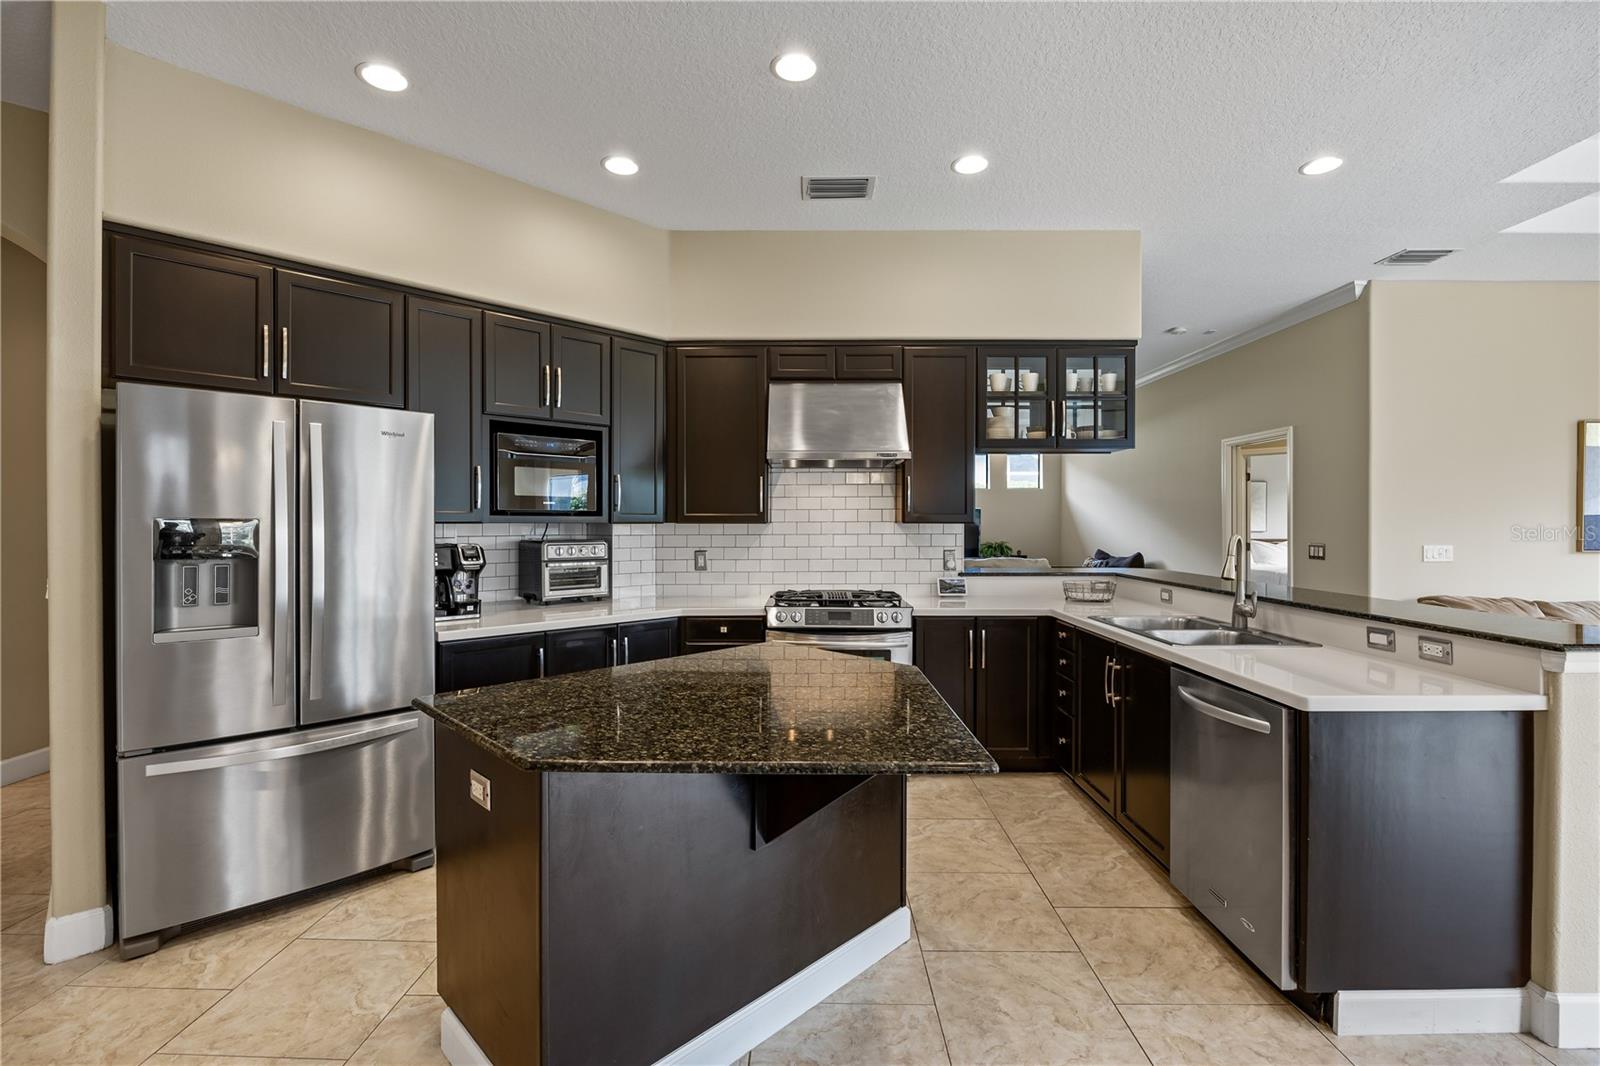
[1074,634,1171,866]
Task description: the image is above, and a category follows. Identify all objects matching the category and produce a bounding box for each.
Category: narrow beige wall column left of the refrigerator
[45,0,112,962]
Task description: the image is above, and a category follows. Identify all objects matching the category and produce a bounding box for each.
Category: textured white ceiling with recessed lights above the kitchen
[96,3,1600,368]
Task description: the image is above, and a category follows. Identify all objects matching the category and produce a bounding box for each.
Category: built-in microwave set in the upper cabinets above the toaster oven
[490,423,605,519]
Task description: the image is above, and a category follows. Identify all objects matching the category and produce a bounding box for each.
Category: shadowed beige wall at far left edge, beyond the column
[0,240,50,759]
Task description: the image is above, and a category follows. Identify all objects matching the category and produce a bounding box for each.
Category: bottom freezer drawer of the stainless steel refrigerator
[117,711,434,940]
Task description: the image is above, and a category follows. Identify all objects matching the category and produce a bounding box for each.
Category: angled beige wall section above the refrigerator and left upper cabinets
[106,45,669,336]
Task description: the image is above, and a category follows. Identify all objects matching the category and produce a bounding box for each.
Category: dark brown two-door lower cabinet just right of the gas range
[914,618,1054,770]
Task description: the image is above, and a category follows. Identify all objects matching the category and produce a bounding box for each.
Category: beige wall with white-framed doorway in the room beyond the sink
[1059,298,1368,592]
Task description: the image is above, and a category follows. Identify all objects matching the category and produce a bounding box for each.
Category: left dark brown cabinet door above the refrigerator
[107,234,272,392]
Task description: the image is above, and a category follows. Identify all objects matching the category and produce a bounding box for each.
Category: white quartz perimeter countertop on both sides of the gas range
[438,586,1547,711]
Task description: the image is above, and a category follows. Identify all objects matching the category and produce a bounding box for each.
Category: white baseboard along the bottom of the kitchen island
[438,908,910,1066]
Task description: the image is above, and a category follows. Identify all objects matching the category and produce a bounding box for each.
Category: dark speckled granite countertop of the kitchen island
[413,643,998,773]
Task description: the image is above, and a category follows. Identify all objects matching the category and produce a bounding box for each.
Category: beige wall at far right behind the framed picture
[1363,282,1600,600]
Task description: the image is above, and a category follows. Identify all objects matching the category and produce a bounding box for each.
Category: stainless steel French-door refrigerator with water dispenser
[110,384,434,957]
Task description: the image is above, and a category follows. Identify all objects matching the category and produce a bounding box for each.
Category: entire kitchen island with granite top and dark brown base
[416,643,997,1066]
